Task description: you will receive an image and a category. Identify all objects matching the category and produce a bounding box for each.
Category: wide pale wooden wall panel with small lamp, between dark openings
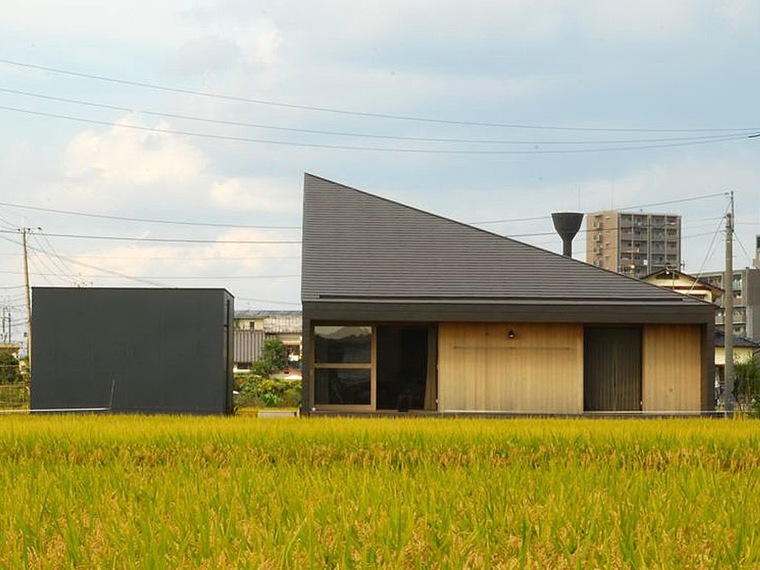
[438,323,583,413]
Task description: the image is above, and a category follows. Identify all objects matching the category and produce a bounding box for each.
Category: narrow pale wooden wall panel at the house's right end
[642,325,702,412]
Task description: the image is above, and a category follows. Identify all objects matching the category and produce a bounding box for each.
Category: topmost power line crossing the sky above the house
[0,58,760,133]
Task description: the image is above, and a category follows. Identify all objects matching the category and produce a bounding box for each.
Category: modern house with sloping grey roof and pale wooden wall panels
[301,174,715,414]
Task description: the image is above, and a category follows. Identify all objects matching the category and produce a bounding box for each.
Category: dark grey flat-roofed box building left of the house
[31,287,234,414]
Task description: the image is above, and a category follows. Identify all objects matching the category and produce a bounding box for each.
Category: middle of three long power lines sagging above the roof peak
[0,87,754,145]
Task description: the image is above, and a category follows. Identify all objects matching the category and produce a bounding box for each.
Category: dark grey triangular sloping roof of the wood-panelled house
[301,174,705,306]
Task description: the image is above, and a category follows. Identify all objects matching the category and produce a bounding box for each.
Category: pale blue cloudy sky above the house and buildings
[0,0,760,339]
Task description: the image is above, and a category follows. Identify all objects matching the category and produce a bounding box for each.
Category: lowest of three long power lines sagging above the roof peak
[0,103,750,155]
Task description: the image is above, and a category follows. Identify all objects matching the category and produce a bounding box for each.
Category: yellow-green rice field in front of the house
[0,415,760,569]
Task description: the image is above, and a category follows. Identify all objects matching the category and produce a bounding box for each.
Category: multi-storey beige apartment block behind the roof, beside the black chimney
[586,211,681,278]
